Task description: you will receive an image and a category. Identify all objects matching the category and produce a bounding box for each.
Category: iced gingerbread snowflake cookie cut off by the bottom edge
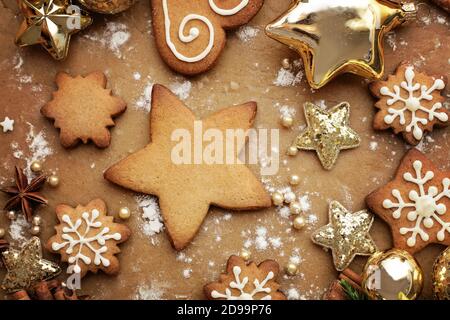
[203,256,286,300]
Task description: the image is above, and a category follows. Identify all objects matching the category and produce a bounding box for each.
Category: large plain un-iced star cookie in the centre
[105,85,271,250]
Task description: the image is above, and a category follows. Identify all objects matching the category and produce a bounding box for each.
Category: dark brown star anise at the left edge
[1,167,48,222]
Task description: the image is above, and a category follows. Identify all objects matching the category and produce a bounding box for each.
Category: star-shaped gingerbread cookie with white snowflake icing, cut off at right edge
[366,149,450,254]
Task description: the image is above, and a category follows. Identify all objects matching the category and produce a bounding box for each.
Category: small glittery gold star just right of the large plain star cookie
[292,102,361,170]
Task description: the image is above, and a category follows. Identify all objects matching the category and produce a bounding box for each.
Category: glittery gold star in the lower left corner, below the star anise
[2,237,61,293]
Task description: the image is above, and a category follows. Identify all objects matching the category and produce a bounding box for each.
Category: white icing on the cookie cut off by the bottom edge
[211,266,275,300]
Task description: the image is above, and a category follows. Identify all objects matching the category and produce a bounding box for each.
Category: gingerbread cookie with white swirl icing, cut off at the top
[151,0,264,75]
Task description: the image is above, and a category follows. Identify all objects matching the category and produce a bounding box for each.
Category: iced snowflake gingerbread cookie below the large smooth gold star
[370,63,450,145]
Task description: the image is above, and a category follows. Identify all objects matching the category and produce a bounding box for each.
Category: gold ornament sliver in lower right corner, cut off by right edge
[433,247,450,300]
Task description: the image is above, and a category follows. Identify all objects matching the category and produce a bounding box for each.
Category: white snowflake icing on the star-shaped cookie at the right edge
[383,160,450,247]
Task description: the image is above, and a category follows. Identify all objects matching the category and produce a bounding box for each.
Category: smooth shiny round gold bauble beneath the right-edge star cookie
[361,249,423,300]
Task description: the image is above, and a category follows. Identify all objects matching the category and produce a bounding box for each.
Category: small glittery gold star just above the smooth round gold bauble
[311,201,377,271]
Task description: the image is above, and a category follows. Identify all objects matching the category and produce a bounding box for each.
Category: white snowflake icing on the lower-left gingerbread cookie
[52,209,122,273]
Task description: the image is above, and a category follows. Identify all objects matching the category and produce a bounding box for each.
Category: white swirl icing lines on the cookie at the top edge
[162,0,249,63]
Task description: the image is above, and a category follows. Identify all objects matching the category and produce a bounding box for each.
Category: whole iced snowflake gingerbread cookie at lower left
[46,199,131,277]
